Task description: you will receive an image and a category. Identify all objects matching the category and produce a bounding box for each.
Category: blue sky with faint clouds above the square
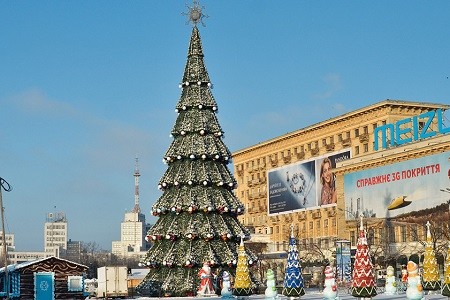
[0,0,450,251]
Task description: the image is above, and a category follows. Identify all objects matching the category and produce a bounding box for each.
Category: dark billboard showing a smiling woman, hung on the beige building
[267,149,351,215]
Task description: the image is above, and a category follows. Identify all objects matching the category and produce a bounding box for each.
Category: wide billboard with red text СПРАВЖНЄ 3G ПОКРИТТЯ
[344,152,450,218]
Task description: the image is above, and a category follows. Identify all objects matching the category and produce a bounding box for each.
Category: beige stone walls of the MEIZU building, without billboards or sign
[233,100,450,260]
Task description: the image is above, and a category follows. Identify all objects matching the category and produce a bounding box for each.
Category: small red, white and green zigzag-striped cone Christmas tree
[352,216,377,298]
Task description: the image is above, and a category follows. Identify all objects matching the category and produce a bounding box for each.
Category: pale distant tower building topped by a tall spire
[112,158,150,257]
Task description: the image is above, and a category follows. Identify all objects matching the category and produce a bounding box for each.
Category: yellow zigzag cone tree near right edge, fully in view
[422,222,441,291]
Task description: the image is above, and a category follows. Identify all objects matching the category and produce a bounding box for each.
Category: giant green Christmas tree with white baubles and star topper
[137,1,257,296]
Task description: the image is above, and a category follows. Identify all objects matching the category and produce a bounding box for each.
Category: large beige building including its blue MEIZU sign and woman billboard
[233,100,450,261]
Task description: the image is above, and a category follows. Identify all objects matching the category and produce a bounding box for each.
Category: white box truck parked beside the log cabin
[97,266,128,299]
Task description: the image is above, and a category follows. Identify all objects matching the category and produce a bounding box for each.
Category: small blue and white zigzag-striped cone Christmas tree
[282,225,305,297]
